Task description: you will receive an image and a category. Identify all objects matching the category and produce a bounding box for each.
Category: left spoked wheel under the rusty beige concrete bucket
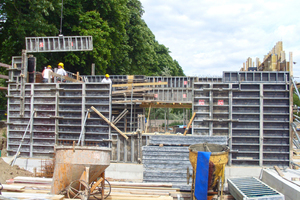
[67,180,90,200]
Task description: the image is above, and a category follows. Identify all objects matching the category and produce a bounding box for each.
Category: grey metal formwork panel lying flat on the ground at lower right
[227,177,284,200]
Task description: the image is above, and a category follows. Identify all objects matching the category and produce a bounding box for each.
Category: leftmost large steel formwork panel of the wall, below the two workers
[7,84,56,157]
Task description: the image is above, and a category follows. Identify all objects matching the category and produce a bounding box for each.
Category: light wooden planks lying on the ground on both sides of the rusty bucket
[0,177,191,200]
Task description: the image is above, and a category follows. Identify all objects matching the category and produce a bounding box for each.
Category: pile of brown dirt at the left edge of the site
[0,127,33,184]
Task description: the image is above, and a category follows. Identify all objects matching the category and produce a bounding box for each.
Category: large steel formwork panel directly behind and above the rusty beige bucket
[57,83,111,147]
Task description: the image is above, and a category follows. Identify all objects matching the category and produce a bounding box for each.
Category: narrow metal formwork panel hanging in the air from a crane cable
[25,36,93,53]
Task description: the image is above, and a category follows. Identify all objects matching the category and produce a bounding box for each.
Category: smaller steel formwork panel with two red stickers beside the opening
[193,82,231,136]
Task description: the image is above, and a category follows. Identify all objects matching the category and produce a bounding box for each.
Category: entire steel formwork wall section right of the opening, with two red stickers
[193,72,290,166]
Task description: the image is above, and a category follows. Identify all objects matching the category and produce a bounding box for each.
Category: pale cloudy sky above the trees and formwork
[140,0,300,77]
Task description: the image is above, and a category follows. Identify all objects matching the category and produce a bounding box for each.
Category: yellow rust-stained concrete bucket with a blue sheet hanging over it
[187,143,229,199]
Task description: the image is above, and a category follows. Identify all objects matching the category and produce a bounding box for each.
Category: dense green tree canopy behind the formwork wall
[0,0,184,76]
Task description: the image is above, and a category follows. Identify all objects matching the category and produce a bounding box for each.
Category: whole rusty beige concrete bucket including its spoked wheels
[51,146,111,200]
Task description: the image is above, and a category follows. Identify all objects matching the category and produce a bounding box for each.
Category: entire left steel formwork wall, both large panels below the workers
[7,83,111,157]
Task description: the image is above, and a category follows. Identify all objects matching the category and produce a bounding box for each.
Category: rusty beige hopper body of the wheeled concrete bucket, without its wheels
[51,146,111,194]
